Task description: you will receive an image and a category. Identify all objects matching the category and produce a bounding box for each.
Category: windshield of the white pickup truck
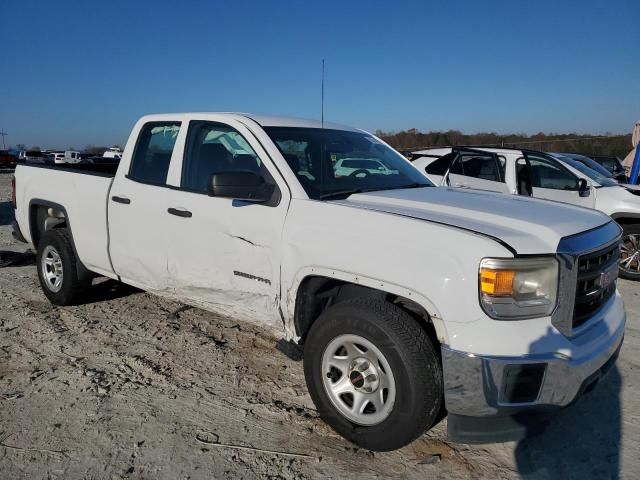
[265,127,433,199]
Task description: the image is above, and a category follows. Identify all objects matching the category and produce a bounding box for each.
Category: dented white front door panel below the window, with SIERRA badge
[167,190,285,333]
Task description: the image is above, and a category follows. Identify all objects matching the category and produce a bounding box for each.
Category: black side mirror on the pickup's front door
[209,170,275,202]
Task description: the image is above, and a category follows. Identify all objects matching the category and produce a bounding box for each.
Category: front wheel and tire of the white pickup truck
[304,298,443,451]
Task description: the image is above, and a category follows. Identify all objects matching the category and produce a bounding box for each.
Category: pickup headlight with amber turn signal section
[478,257,558,320]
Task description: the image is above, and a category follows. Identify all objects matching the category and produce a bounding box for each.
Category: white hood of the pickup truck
[335,187,611,254]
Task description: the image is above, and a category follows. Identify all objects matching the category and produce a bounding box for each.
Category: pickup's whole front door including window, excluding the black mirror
[165,116,289,328]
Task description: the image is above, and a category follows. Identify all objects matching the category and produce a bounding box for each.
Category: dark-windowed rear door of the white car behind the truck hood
[448,149,509,193]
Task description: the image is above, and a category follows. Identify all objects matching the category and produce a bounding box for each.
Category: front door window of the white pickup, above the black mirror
[181,121,271,193]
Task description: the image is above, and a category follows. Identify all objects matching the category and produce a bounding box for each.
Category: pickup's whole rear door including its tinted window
[108,121,181,291]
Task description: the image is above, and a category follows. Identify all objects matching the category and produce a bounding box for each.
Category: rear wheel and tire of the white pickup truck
[36,228,91,306]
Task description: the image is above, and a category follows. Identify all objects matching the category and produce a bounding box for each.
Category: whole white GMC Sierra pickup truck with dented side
[14,113,626,451]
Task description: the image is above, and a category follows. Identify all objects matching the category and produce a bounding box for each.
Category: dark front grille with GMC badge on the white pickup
[572,242,620,328]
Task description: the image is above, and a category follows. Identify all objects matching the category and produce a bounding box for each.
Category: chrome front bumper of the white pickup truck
[442,313,626,442]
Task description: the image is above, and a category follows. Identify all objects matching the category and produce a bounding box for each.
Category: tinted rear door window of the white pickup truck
[129,122,180,185]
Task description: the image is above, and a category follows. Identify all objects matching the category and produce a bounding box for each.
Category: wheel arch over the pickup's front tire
[289,267,448,344]
